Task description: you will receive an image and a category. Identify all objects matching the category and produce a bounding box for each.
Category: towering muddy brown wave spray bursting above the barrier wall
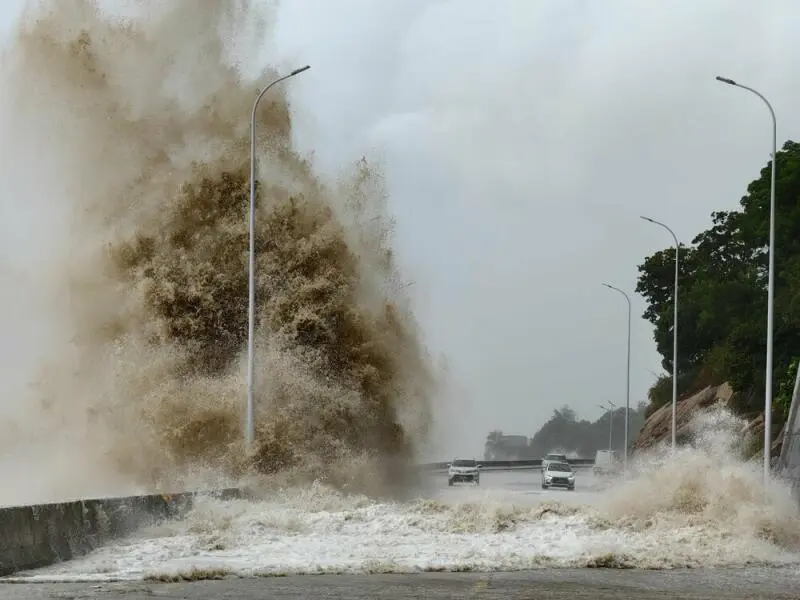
[2,0,434,500]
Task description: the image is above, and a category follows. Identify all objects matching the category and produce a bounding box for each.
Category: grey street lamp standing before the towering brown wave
[245,65,311,448]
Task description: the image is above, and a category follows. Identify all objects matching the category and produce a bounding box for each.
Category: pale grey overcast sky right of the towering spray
[0,0,800,458]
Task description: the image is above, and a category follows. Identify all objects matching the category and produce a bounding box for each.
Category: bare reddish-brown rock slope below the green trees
[632,383,784,457]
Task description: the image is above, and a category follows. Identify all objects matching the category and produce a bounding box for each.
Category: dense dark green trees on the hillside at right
[636,141,800,418]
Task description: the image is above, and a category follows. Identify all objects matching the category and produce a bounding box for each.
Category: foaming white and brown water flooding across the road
[10,410,800,581]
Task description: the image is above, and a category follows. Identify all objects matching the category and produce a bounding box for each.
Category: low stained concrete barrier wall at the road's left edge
[0,489,241,576]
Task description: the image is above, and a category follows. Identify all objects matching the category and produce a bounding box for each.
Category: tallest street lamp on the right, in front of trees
[716,76,778,486]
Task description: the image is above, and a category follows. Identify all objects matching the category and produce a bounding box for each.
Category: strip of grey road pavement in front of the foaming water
[0,568,800,600]
